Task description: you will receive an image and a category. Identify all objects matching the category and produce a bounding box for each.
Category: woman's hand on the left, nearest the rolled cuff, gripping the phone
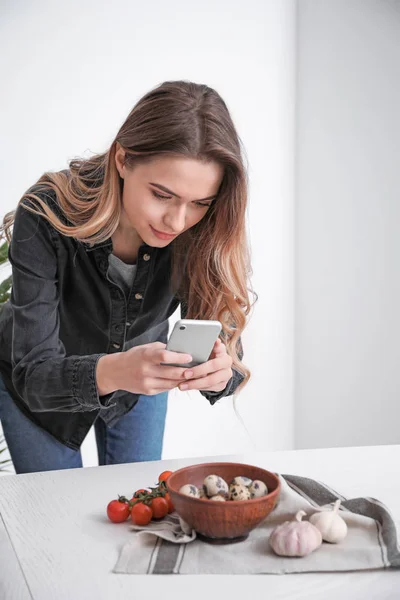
[96,342,192,396]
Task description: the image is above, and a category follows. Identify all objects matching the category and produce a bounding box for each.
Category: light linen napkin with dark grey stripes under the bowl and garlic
[114,475,400,575]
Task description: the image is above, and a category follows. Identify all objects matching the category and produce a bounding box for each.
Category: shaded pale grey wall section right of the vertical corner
[296,0,400,448]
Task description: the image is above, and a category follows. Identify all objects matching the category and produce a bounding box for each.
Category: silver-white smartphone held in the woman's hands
[164,319,222,367]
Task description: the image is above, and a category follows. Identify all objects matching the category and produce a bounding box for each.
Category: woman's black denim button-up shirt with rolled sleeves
[0,192,243,449]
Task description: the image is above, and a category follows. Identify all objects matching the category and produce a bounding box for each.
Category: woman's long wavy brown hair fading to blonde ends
[2,81,252,385]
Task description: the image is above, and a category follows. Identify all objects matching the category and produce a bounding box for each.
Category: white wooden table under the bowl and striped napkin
[0,445,400,600]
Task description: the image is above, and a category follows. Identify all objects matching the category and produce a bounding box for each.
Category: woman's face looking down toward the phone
[115,147,223,248]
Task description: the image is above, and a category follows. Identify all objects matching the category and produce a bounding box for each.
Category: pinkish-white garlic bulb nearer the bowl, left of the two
[269,510,322,556]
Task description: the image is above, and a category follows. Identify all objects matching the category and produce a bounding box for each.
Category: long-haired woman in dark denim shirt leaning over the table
[0,81,250,473]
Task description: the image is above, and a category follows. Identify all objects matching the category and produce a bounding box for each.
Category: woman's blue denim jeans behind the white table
[0,376,168,473]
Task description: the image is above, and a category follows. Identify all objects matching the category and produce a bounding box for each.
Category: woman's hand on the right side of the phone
[178,338,233,392]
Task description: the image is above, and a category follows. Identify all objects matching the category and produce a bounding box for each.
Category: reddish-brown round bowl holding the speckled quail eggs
[166,462,280,543]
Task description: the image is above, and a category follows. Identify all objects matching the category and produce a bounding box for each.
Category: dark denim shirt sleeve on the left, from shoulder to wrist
[9,205,108,412]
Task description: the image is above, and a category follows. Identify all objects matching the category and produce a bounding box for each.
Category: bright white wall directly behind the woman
[0,0,295,465]
